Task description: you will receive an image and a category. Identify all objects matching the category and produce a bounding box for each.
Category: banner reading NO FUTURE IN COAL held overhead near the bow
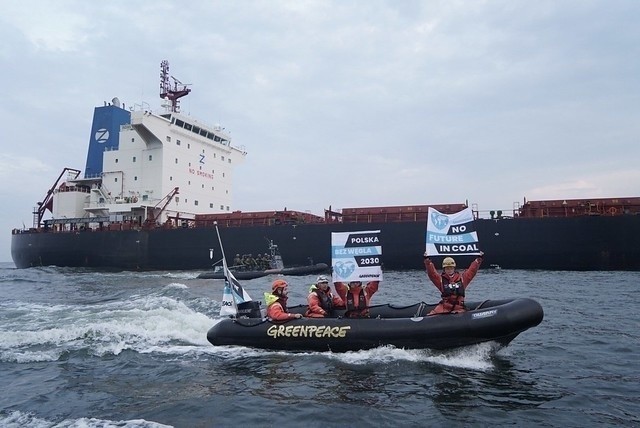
[426,207,480,256]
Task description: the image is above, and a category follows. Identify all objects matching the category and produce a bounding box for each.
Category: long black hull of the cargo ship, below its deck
[11,215,640,270]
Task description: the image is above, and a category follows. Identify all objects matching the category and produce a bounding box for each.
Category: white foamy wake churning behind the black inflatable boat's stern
[0,296,219,363]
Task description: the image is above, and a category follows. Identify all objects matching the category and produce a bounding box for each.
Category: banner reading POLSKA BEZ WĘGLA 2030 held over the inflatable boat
[331,230,382,282]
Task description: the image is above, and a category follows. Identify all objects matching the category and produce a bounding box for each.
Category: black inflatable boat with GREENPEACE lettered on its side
[207,298,544,352]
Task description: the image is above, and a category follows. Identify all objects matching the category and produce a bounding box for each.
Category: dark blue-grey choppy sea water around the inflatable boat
[0,264,640,427]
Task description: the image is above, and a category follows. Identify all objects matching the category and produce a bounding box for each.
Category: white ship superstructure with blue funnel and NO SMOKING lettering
[42,63,246,230]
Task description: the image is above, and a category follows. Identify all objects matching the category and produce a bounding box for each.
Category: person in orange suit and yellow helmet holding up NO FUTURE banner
[424,251,484,315]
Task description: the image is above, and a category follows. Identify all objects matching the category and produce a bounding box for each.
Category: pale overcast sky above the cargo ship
[0,0,640,261]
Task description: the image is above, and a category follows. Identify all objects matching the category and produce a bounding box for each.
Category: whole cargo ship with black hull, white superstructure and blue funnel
[11,61,640,270]
